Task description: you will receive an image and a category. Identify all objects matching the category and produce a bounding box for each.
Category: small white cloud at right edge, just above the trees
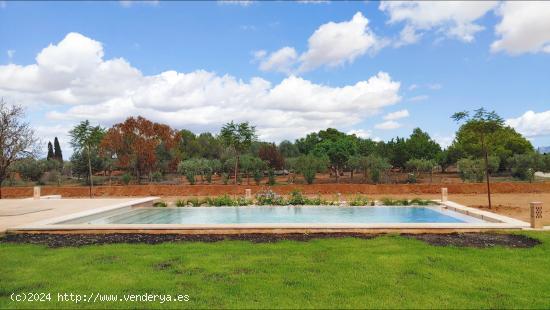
[506,110,550,137]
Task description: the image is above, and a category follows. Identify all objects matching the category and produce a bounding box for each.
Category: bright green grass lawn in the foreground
[0,232,550,308]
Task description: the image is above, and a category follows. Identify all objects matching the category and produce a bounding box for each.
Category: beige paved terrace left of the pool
[0,197,157,234]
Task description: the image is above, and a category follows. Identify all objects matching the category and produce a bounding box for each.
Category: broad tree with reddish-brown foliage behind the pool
[101,116,178,183]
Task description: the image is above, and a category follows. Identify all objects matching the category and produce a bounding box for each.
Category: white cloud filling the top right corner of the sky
[491,1,550,55]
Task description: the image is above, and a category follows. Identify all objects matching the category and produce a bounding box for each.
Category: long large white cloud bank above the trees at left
[0,33,401,145]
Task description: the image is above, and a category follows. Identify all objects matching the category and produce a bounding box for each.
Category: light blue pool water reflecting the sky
[59,206,480,224]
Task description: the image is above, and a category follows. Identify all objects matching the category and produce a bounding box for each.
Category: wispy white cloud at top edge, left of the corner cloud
[379,1,498,46]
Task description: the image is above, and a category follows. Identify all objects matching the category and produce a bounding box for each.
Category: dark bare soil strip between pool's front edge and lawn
[0,233,540,248]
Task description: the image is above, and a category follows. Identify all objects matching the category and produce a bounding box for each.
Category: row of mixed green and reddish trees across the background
[0,101,550,201]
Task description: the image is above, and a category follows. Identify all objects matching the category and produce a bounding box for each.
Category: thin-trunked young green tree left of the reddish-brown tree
[69,120,105,198]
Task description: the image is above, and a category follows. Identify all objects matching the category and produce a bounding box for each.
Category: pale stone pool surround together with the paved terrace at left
[0,197,529,234]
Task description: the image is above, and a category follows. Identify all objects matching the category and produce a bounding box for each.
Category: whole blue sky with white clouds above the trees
[0,1,550,152]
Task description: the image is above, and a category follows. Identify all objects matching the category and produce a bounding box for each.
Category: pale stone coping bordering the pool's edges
[7,197,529,234]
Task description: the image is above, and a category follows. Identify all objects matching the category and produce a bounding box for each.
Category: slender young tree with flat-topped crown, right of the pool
[451,108,505,209]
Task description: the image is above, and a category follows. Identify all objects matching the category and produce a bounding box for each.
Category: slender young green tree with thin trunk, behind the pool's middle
[220,121,256,184]
